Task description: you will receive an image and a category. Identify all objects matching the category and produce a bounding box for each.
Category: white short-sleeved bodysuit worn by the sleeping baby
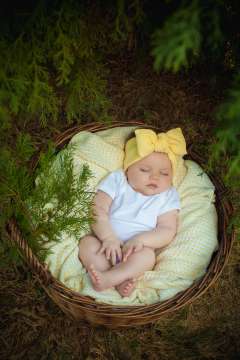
[97,170,180,241]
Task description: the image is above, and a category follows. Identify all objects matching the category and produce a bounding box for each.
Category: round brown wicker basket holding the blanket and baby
[7,121,235,328]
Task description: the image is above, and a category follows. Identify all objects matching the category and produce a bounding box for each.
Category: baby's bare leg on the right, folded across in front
[89,247,155,291]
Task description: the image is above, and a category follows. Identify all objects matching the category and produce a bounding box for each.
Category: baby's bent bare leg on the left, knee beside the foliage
[78,235,111,271]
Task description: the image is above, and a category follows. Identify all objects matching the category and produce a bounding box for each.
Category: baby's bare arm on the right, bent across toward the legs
[123,210,178,261]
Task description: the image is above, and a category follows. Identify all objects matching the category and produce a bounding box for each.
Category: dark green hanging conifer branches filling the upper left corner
[0,0,150,126]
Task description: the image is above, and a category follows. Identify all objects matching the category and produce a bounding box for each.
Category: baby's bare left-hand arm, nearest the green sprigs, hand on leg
[92,190,122,265]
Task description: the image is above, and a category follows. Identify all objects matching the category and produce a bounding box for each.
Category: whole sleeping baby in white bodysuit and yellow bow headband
[79,128,186,296]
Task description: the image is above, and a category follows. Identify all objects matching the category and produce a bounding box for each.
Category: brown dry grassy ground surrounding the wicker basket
[0,56,240,360]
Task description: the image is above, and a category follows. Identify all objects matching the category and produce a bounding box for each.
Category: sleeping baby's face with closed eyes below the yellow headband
[126,152,172,195]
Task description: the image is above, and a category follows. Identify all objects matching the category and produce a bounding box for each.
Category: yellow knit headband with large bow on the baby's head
[123,128,187,173]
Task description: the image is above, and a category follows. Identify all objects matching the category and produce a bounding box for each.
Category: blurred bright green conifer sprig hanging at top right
[152,0,201,72]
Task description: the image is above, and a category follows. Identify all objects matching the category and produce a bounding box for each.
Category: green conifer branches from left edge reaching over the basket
[0,133,93,263]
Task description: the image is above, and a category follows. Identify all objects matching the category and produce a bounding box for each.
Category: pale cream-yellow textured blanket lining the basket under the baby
[46,127,217,305]
